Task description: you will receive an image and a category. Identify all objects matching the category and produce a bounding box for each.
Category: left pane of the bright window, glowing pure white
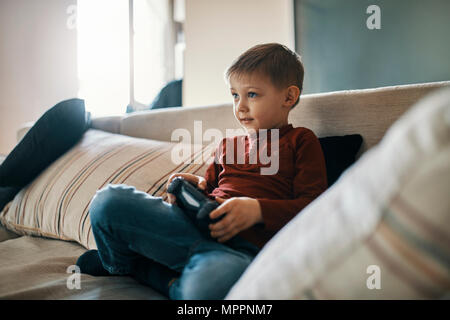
[77,0,130,117]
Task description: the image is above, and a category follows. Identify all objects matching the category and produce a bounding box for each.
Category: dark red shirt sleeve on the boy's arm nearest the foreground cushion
[257,131,327,232]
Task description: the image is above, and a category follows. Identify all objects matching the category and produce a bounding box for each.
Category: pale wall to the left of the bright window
[0,0,78,154]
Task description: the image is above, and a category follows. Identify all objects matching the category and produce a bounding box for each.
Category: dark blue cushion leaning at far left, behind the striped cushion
[0,99,91,210]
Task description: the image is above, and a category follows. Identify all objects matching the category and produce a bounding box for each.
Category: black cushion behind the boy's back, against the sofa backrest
[319,134,363,187]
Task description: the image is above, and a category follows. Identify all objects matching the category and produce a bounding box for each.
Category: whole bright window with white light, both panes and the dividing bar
[77,0,184,116]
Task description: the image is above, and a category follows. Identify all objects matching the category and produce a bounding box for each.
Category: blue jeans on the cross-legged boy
[90,184,259,299]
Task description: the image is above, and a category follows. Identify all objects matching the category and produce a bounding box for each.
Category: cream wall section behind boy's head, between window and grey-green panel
[183,0,295,106]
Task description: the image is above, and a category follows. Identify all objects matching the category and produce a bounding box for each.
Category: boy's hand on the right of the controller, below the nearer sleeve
[209,197,263,242]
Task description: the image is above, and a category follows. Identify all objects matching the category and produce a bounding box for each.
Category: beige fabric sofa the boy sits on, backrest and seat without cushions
[0,81,450,299]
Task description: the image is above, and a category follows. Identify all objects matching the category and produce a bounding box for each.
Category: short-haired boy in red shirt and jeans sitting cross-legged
[77,43,327,299]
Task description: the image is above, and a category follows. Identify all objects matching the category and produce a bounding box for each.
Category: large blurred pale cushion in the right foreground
[227,89,450,299]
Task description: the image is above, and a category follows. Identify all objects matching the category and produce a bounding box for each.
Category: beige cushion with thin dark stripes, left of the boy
[0,129,213,249]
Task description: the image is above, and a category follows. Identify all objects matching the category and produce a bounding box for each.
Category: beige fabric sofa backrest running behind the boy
[93,81,450,154]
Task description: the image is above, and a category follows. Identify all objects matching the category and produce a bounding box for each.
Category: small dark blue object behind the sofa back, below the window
[127,79,183,113]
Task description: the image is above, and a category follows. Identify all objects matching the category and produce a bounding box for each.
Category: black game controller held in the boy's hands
[167,177,223,233]
